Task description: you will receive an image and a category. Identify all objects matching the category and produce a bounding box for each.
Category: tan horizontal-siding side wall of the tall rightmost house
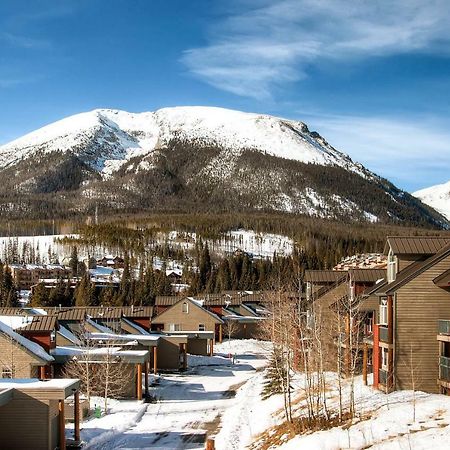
[394,256,450,393]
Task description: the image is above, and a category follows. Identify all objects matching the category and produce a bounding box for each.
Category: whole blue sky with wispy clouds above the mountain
[0,0,450,191]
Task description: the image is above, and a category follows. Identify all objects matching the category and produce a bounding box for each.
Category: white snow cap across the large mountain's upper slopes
[0,107,369,176]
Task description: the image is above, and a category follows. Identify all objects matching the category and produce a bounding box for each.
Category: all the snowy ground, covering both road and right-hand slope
[68,340,450,450]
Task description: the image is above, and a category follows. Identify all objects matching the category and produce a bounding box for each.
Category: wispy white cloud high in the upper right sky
[181,0,450,99]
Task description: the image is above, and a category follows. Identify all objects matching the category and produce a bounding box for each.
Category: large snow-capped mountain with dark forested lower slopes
[0,107,443,225]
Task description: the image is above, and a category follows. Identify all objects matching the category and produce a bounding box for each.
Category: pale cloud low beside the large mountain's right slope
[301,113,450,191]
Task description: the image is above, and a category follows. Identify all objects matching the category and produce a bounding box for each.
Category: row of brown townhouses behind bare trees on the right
[304,236,450,395]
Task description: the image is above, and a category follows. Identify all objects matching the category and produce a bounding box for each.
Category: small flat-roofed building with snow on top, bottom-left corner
[0,379,80,450]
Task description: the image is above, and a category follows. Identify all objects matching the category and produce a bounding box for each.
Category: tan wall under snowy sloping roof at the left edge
[0,333,45,378]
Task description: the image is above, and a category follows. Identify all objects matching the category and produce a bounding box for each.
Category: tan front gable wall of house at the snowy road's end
[154,301,217,332]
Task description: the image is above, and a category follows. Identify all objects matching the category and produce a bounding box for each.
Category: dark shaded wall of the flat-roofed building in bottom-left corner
[0,391,50,450]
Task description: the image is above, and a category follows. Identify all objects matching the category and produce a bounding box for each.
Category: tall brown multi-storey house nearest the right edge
[372,236,450,393]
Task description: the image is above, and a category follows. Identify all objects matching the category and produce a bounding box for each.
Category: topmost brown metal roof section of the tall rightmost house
[385,236,450,255]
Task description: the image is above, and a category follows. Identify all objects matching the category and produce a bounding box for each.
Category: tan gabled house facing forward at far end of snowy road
[151,297,223,342]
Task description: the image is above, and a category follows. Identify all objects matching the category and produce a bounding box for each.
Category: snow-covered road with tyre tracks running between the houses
[68,340,269,450]
